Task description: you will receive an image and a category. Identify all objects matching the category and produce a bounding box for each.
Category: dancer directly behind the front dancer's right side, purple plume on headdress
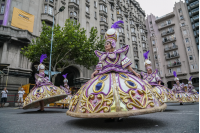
[141,51,178,102]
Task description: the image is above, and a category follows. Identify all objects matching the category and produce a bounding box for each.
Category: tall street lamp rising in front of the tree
[49,6,65,81]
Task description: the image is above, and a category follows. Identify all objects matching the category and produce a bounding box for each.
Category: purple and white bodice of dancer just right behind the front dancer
[141,70,162,85]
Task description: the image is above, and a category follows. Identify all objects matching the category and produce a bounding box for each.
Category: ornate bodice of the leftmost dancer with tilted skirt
[35,72,53,86]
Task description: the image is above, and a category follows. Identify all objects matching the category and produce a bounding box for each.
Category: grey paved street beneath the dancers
[0,103,199,133]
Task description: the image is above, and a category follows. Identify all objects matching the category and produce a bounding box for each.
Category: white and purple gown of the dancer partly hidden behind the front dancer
[141,70,178,102]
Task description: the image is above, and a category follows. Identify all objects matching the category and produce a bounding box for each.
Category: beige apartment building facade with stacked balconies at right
[146,1,199,88]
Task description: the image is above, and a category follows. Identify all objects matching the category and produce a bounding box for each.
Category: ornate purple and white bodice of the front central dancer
[95,45,132,75]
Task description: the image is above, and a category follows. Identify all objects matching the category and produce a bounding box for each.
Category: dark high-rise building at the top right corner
[185,0,199,50]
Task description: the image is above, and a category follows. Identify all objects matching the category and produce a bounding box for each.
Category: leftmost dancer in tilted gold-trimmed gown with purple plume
[23,54,67,111]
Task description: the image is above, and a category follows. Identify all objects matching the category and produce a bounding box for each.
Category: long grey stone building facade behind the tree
[0,0,148,95]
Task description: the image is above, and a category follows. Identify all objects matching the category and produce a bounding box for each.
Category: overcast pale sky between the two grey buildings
[137,0,182,17]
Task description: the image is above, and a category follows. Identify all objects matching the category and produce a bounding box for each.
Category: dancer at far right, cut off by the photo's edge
[186,76,199,102]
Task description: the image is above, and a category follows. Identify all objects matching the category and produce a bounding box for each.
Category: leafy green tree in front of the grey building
[21,19,105,71]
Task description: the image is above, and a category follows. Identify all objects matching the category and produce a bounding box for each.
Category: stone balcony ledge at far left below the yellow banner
[0,25,36,42]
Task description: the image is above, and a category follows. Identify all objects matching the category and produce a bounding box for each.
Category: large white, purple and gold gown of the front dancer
[67,46,167,118]
